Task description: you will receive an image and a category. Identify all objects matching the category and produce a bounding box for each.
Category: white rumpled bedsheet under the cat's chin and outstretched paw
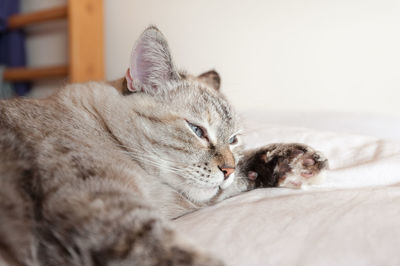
[175,112,400,266]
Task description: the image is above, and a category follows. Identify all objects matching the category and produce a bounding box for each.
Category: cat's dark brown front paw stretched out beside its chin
[246,143,328,188]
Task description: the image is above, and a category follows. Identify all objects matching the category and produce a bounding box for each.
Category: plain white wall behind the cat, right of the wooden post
[105,0,400,115]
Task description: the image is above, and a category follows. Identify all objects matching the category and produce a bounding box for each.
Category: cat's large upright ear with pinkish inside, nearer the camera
[125,26,179,94]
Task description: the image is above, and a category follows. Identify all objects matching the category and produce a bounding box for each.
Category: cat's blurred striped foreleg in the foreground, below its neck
[40,179,223,266]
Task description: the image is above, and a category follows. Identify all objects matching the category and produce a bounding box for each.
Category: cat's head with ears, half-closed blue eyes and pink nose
[120,27,241,202]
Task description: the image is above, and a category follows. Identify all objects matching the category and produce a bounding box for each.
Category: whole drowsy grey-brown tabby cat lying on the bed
[0,27,327,266]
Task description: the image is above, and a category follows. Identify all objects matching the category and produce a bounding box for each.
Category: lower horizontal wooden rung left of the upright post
[3,65,68,82]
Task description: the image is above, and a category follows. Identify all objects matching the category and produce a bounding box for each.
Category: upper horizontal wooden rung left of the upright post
[8,6,68,29]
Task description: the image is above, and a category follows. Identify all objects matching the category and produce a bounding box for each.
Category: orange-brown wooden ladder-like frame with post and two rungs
[4,0,104,82]
